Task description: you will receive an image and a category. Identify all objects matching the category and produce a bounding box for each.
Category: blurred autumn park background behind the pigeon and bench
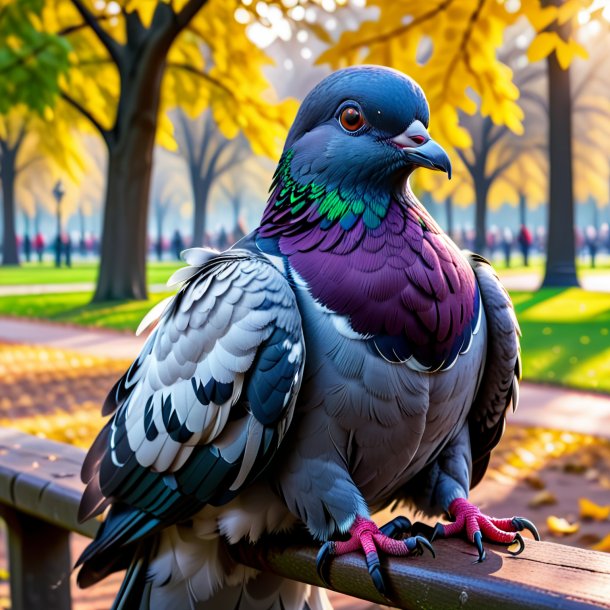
[0,0,610,608]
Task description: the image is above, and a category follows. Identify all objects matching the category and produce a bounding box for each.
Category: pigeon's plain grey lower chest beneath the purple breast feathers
[294,279,484,505]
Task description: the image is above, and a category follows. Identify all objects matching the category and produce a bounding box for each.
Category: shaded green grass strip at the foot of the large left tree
[0,291,174,331]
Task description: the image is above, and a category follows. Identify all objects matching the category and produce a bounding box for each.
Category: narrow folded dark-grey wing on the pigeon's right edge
[466,253,521,487]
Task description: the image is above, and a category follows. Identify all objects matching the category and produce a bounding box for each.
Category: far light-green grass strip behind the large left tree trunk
[0,261,180,286]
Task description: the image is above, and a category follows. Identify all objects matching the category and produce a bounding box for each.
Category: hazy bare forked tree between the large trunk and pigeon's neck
[175,112,252,246]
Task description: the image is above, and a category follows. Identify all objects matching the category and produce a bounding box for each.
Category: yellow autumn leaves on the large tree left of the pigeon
[36,0,297,164]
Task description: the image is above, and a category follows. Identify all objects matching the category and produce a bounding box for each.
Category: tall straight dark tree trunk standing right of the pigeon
[542,0,579,287]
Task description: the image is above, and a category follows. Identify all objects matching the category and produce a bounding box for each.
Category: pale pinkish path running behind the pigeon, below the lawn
[0,317,610,438]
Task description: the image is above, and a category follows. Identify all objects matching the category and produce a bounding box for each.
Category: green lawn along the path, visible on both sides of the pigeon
[0,288,610,393]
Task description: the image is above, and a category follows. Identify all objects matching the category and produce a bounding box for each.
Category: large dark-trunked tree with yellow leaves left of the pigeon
[27,0,294,301]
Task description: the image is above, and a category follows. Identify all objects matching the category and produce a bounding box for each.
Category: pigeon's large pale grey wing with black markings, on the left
[80,249,305,576]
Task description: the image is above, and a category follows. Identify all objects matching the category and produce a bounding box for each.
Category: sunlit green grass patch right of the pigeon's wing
[511,288,610,393]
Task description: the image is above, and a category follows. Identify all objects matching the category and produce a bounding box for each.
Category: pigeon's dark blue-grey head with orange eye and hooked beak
[284,66,451,194]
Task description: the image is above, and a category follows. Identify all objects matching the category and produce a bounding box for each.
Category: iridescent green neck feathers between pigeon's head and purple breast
[261,150,391,236]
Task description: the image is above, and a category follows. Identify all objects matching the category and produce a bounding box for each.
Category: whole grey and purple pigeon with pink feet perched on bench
[77,66,538,610]
